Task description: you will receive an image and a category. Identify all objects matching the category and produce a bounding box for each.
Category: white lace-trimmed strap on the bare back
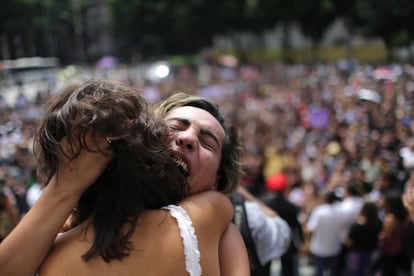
[163,205,201,276]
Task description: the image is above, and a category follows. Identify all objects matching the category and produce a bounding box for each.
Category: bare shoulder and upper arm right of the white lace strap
[180,191,250,276]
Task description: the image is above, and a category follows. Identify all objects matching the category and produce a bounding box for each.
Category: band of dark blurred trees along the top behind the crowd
[0,0,414,60]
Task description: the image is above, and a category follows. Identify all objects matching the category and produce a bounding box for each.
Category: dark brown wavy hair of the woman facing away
[35,80,188,262]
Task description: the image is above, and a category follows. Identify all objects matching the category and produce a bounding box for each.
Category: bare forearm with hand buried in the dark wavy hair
[0,136,110,276]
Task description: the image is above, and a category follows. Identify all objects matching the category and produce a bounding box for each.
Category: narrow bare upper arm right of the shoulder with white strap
[219,223,250,276]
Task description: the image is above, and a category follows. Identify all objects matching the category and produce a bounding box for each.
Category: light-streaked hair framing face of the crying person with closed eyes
[156,92,243,194]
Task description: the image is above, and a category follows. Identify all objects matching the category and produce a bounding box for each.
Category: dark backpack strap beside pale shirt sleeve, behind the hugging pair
[229,192,262,271]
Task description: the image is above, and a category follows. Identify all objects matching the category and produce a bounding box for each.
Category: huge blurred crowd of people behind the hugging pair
[0,58,414,275]
